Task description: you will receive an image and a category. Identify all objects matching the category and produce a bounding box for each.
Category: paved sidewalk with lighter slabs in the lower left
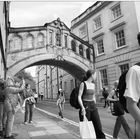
[13,109,79,139]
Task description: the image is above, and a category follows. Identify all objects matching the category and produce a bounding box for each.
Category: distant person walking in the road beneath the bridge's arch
[57,89,65,118]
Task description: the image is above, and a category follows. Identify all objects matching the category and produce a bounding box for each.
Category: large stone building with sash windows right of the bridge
[71,1,140,95]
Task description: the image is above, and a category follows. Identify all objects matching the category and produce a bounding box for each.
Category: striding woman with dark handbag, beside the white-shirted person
[107,81,133,139]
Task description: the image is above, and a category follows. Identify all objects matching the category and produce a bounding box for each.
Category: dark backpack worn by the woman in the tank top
[69,82,86,109]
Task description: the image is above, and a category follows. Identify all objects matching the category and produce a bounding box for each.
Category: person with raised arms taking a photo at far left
[3,78,25,139]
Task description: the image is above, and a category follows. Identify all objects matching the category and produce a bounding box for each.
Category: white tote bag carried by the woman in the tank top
[79,116,96,139]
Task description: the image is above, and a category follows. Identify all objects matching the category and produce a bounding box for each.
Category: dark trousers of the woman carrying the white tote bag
[79,101,105,139]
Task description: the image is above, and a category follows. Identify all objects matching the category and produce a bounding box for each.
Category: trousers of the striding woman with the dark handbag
[113,115,134,139]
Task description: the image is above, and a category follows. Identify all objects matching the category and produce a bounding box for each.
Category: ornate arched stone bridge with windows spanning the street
[7,18,94,80]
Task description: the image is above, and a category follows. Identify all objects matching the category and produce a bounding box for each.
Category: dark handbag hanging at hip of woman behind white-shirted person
[110,101,124,116]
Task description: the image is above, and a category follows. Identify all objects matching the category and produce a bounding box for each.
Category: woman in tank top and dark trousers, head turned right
[78,70,105,139]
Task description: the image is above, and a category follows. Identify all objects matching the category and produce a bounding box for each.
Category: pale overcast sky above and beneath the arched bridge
[10,0,94,76]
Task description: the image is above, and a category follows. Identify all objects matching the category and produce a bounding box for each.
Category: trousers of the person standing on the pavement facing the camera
[24,102,34,122]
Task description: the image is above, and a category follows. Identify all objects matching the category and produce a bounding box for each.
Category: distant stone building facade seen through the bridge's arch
[36,65,75,100]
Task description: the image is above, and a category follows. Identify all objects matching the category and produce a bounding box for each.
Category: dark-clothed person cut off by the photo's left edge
[0,79,5,137]
